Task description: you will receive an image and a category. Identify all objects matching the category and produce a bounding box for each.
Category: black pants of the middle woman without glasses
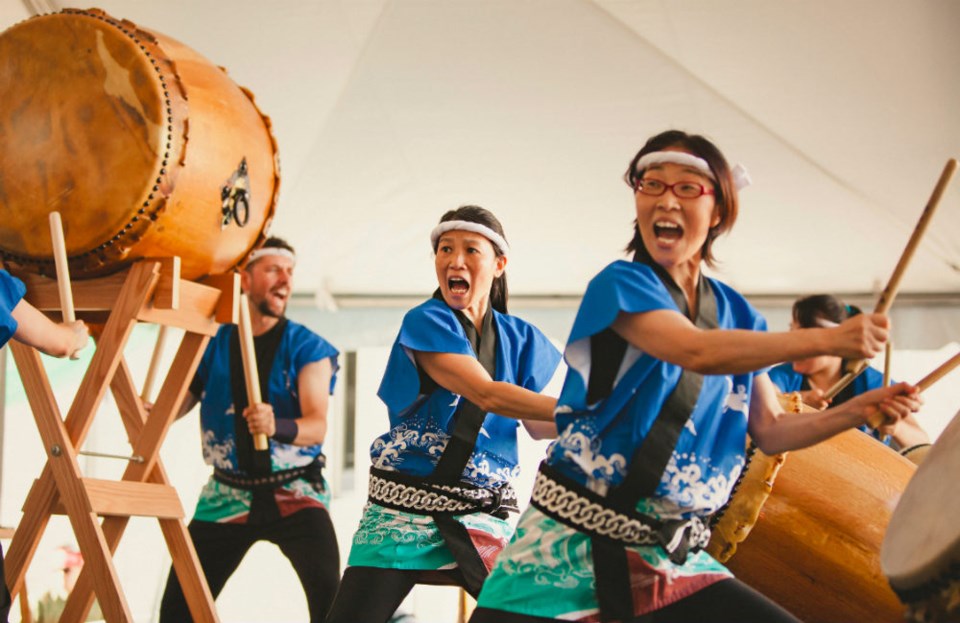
[327,567,464,623]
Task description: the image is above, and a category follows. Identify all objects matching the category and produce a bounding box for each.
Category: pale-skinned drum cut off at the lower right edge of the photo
[880,413,960,623]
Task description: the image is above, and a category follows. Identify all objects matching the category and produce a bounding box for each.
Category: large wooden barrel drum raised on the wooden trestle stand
[0,9,280,279]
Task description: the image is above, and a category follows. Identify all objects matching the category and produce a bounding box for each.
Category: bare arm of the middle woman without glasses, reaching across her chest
[414,351,557,424]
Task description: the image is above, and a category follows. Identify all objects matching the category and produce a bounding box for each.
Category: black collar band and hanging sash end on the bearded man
[230,318,287,523]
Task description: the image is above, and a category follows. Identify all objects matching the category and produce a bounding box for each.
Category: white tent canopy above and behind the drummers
[0,0,960,296]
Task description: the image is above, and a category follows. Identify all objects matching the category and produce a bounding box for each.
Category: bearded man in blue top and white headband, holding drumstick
[160,237,340,623]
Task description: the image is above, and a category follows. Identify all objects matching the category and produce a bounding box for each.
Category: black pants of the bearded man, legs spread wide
[160,508,340,623]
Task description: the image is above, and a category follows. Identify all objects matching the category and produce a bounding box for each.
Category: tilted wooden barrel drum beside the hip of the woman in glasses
[708,416,916,623]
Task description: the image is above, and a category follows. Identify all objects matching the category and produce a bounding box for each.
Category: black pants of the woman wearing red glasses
[470,580,800,623]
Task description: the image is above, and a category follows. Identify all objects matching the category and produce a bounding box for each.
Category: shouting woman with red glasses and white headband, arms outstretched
[471,131,919,623]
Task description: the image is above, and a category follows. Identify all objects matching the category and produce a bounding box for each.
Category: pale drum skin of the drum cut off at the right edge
[880,413,960,593]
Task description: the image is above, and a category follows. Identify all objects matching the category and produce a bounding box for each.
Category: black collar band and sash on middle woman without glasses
[426,295,497,597]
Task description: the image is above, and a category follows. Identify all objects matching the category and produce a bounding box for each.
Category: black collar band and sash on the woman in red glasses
[590,254,719,621]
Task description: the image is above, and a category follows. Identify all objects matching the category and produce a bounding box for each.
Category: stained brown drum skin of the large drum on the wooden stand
[0,15,171,257]
